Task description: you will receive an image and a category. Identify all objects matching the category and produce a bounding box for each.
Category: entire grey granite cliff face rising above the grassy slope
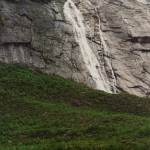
[0,0,150,96]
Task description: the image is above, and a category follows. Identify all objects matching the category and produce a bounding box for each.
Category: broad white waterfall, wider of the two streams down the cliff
[64,0,114,93]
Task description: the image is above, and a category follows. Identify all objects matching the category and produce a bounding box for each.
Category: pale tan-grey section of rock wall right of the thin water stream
[96,0,150,96]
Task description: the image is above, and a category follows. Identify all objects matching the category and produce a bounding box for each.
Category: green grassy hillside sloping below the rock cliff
[0,63,150,150]
